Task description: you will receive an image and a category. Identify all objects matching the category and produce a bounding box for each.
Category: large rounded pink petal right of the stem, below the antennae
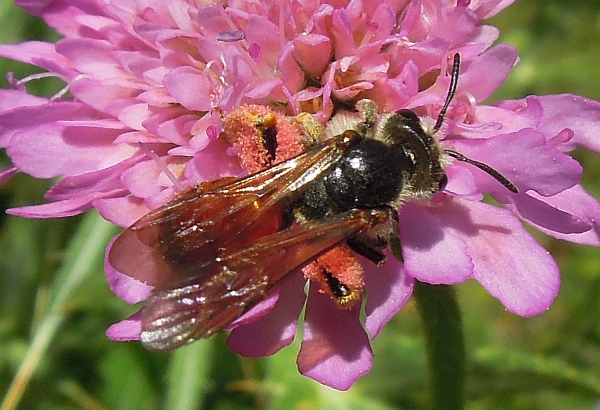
[432,199,560,316]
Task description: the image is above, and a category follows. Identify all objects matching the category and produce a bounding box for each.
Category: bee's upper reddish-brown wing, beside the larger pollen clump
[109,138,342,289]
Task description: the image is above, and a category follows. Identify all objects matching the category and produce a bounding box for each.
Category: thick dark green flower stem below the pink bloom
[413,282,466,410]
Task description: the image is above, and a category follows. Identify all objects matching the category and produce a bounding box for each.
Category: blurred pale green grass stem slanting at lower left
[0,212,115,410]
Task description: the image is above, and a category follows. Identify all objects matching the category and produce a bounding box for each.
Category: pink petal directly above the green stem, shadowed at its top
[399,200,473,284]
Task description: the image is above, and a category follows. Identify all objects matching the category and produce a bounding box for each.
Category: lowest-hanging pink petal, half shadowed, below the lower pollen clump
[297,286,373,390]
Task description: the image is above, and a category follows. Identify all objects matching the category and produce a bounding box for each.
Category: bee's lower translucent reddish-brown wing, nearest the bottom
[142,209,388,350]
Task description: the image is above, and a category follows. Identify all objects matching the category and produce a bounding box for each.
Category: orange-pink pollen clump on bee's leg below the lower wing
[302,245,364,309]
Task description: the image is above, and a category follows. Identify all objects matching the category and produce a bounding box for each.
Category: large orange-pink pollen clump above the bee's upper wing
[223,104,304,173]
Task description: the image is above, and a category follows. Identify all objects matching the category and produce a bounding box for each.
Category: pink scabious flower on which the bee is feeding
[0,0,600,389]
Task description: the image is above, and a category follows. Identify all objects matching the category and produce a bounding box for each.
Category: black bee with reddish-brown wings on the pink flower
[109,54,518,350]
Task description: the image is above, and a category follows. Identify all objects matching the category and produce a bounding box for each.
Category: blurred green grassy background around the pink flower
[0,0,600,410]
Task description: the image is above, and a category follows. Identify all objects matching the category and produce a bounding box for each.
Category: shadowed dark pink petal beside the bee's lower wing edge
[227,272,306,357]
